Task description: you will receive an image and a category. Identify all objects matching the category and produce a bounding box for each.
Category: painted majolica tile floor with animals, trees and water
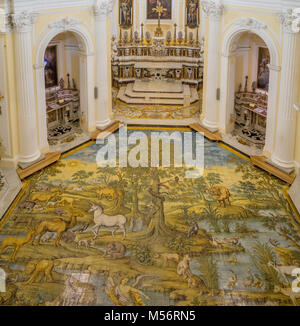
[0,127,300,306]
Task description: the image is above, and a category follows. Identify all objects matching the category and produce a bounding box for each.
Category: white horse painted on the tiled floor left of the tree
[89,204,127,240]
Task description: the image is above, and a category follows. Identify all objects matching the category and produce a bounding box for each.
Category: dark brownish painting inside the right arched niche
[257,47,270,90]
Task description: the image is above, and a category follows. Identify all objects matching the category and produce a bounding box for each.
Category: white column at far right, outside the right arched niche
[271,13,299,172]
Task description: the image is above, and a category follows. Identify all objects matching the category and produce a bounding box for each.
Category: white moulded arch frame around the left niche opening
[34,18,95,150]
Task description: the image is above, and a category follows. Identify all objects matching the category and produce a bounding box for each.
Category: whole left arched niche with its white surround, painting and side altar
[35,19,95,151]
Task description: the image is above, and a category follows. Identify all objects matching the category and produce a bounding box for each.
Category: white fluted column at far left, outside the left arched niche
[11,12,41,163]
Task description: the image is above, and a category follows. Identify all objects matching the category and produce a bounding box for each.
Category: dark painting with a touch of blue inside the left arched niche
[44,45,58,88]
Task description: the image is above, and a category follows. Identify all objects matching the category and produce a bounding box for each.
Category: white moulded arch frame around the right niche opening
[220,17,280,156]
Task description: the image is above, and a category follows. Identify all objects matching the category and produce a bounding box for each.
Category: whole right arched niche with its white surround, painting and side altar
[220,18,280,156]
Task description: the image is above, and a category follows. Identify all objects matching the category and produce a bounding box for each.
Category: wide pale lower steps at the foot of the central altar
[118,83,199,106]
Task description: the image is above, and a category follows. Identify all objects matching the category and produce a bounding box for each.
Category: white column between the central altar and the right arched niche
[201,1,223,132]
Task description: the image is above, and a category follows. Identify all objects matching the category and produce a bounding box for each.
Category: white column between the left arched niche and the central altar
[94,0,113,129]
